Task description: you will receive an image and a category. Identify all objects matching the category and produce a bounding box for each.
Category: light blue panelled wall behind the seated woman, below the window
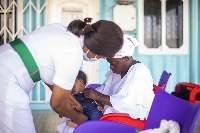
[99,0,192,93]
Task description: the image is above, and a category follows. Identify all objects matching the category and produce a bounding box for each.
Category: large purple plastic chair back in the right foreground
[145,90,200,133]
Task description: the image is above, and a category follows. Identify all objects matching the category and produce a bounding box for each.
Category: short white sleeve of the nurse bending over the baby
[53,49,83,90]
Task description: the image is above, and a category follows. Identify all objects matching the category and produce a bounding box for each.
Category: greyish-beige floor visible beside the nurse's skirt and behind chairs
[32,110,200,133]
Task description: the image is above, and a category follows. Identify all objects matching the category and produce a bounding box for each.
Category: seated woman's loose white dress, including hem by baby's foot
[57,63,155,133]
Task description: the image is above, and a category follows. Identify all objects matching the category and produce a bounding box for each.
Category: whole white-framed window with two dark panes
[138,0,188,54]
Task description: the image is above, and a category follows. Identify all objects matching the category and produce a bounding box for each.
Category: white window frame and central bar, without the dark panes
[138,0,189,54]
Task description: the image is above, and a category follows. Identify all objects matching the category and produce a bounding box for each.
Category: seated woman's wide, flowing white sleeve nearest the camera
[110,65,154,120]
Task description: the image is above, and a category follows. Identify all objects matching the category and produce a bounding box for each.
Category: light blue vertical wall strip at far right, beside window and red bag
[189,0,200,84]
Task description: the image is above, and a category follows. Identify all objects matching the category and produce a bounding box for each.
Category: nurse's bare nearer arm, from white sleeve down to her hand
[50,85,88,124]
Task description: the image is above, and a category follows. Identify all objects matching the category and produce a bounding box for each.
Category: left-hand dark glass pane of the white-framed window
[144,0,161,48]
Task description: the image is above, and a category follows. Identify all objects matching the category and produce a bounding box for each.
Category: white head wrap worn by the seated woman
[113,34,139,58]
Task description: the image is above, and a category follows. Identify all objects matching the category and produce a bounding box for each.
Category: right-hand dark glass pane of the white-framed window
[166,0,183,48]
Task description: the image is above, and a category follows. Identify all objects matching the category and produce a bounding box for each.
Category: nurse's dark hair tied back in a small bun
[67,20,123,57]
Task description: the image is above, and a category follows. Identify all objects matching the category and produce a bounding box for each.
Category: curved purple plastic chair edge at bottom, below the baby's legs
[73,120,137,133]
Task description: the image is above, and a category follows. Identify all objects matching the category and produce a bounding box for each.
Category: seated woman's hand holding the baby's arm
[83,88,102,101]
